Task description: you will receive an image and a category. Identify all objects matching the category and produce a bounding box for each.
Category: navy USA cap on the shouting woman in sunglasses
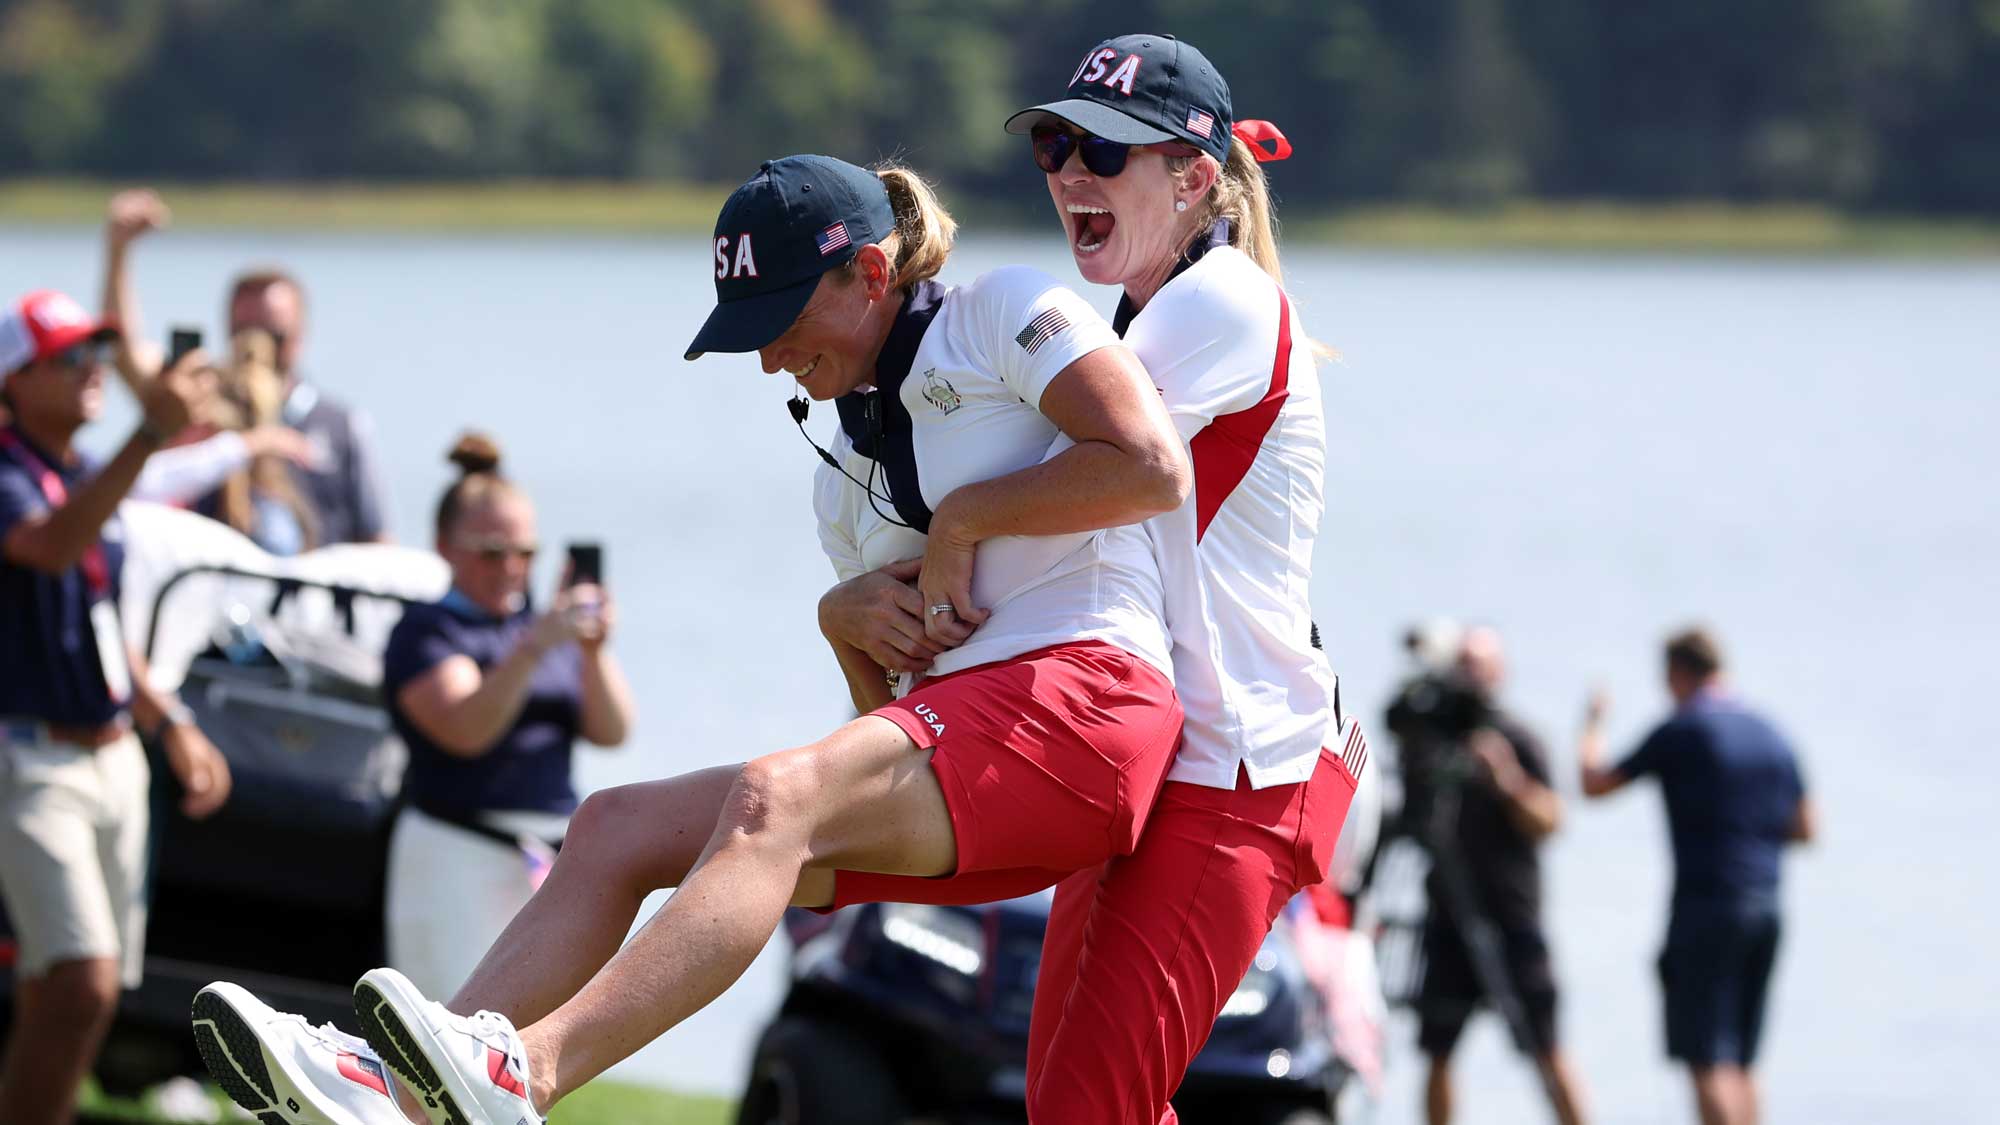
[1006,34,1236,162]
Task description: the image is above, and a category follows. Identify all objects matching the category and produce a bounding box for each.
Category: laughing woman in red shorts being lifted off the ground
[191,156,1188,1125]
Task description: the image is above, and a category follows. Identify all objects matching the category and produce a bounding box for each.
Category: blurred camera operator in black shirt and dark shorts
[1388,627,1584,1125]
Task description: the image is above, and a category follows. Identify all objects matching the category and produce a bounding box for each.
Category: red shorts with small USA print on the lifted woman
[826,641,1180,909]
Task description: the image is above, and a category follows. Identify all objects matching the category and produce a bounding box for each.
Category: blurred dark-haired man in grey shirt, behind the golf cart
[216,268,388,544]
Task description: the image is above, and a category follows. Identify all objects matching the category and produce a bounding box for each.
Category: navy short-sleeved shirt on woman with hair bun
[382,591,584,817]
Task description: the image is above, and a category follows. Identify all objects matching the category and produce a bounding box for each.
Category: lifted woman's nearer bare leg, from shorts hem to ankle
[522,717,958,1111]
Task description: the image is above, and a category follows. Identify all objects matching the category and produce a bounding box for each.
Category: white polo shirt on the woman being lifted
[814,268,1174,677]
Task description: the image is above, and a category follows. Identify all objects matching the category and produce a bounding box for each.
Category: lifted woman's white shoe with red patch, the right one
[354,969,542,1125]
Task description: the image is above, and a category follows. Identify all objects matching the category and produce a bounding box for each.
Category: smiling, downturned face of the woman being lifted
[756,246,900,402]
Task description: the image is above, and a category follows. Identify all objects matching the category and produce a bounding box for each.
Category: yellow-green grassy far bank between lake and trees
[0,180,2000,256]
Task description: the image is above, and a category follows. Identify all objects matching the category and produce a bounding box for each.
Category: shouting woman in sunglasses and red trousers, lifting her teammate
[980,34,1366,1125]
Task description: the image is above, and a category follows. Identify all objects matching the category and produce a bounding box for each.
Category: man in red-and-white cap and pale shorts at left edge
[0,290,230,1125]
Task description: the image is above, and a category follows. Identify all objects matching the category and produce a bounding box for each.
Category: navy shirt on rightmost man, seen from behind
[1618,693,1806,903]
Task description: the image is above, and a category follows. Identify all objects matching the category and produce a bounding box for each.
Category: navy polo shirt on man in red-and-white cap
[0,428,124,727]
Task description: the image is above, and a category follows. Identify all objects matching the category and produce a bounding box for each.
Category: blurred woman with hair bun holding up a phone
[382,434,632,995]
